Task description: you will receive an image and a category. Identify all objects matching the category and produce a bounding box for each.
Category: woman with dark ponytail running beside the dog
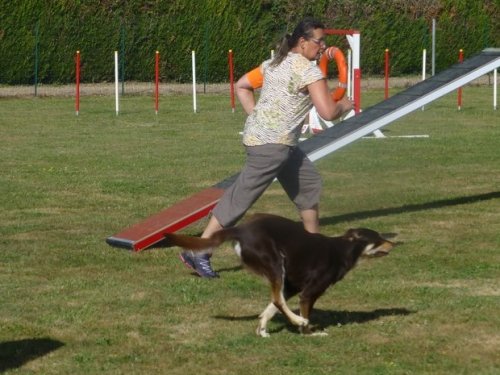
[180,18,352,278]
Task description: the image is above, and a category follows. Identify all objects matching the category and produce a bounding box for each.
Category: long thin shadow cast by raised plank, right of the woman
[320,191,500,225]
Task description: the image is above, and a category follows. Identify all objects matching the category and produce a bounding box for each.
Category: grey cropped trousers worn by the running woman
[212,144,321,227]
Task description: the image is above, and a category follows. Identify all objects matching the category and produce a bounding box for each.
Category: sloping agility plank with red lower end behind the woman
[106,49,500,251]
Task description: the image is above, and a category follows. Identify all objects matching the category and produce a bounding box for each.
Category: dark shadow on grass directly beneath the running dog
[214,308,414,333]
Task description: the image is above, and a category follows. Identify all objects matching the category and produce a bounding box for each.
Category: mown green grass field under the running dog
[0,86,500,375]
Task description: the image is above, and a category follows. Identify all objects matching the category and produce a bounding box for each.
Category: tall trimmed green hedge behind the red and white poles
[0,0,500,84]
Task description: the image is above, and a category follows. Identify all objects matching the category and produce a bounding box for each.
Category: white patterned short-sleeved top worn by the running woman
[243,52,324,146]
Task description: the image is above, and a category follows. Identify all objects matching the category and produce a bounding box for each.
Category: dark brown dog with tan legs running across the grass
[165,214,395,337]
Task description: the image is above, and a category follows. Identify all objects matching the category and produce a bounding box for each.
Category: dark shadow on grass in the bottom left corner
[0,338,64,373]
